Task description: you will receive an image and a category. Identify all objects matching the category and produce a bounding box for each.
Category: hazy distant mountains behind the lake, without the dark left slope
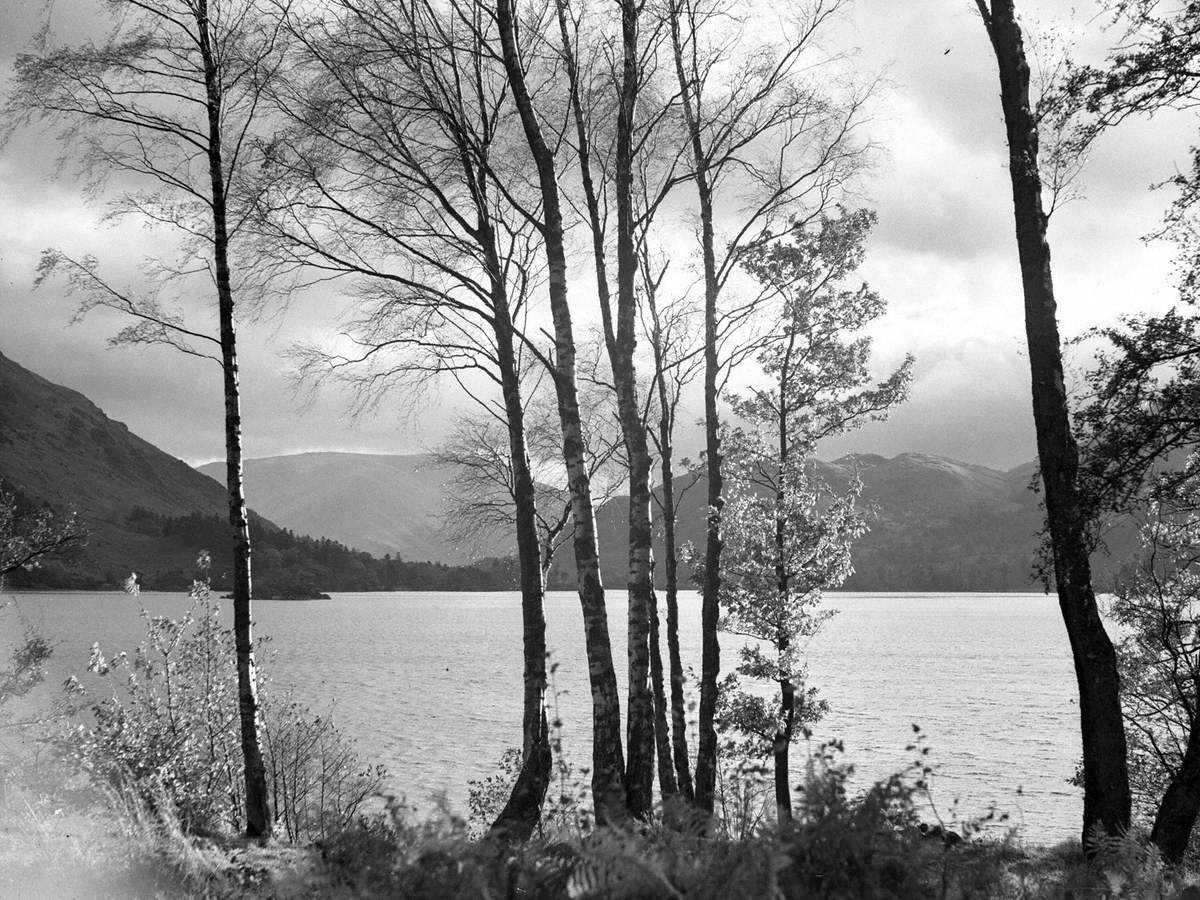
[223,452,1089,590]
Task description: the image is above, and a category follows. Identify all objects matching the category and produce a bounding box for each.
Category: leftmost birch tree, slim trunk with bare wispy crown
[8,0,290,839]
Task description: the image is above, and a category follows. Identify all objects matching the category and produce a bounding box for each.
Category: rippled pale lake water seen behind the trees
[0,592,1082,842]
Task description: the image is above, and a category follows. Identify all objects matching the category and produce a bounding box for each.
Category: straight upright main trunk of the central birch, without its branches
[611,0,661,818]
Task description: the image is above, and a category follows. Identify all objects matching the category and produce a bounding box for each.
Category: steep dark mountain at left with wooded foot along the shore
[0,355,514,599]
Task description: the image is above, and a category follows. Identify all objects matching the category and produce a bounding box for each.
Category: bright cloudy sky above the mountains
[0,0,1195,468]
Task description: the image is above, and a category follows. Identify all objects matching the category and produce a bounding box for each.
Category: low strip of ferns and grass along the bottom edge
[0,776,1200,900]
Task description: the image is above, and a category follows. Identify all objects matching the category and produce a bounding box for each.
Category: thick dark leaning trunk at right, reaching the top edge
[976,0,1130,846]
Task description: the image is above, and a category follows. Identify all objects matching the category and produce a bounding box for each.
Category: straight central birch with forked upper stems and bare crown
[554,0,680,817]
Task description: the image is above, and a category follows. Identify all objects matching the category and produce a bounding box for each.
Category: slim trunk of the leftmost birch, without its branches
[197,12,271,840]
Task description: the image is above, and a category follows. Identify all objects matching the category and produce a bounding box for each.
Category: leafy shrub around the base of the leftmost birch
[58,581,384,842]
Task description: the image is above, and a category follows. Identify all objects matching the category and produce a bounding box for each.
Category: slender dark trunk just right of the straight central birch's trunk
[659,412,696,804]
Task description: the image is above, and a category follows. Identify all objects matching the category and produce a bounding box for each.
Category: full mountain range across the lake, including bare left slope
[0,355,1133,590]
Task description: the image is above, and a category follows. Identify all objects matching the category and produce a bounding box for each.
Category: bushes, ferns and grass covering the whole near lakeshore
[0,581,1200,900]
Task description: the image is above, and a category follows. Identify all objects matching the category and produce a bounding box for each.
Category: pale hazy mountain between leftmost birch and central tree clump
[200,452,484,563]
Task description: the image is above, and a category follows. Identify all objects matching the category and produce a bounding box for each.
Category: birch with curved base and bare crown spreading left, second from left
[262,0,580,840]
